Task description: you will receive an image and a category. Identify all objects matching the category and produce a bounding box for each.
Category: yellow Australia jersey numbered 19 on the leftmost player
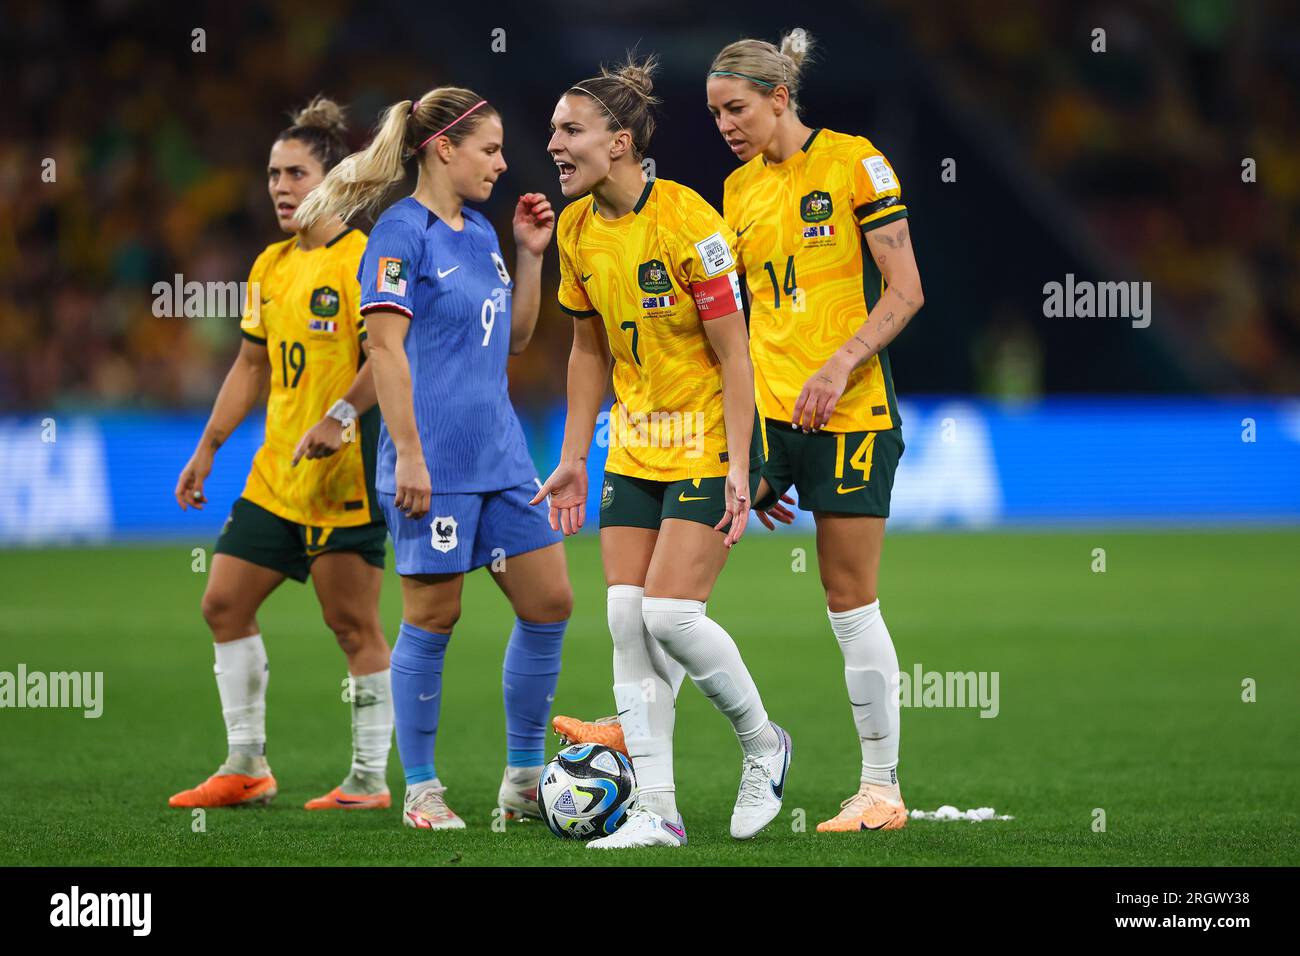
[239,229,380,528]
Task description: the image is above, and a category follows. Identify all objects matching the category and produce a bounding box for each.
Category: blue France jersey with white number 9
[358,196,537,494]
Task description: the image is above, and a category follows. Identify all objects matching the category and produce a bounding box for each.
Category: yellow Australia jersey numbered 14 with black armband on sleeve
[723,129,907,432]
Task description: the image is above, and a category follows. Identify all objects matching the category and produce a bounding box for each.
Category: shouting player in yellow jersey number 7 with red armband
[534,59,790,848]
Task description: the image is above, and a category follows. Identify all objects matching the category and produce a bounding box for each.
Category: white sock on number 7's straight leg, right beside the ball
[607,584,681,819]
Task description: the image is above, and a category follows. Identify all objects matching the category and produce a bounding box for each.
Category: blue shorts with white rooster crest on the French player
[378,479,564,575]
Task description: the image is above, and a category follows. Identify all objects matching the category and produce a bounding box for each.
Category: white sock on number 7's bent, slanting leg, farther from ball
[641,597,781,754]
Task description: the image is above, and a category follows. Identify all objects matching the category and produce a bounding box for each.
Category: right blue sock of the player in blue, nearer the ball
[502,618,568,767]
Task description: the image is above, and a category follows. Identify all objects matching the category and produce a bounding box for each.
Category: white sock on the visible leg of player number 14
[827,600,900,787]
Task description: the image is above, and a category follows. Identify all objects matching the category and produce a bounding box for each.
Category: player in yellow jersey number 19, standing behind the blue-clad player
[169,98,393,810]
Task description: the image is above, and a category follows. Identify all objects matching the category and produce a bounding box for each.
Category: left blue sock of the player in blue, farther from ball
[389,620,451,784]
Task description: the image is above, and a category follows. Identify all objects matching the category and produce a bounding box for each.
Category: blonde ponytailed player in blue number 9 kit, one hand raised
[298,87,573,830]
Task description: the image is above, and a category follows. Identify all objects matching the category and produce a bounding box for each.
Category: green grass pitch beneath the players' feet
[0,525,1300,866]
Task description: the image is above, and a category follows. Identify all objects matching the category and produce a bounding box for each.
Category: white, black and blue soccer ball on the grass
[537,744,637,840]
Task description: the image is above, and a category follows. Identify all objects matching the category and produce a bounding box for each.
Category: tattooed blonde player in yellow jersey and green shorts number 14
[707,30,923,831]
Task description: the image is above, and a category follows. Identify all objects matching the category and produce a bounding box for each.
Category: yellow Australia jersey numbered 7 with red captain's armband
[558,179,753,481]
